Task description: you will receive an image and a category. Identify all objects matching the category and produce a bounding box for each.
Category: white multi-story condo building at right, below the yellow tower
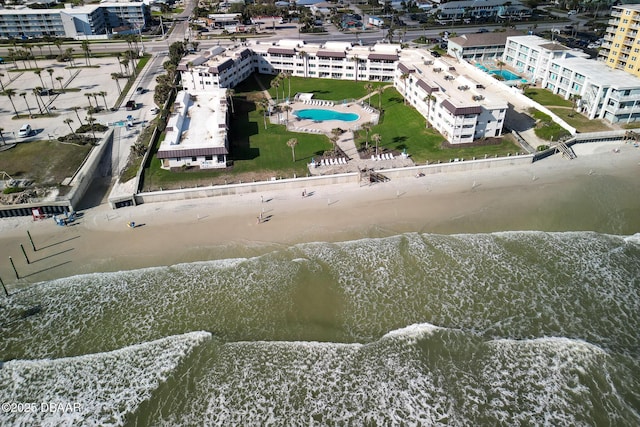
[502,36,640,123]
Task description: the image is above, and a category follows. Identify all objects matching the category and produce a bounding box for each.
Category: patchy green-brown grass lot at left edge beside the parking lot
[0,140,91,185]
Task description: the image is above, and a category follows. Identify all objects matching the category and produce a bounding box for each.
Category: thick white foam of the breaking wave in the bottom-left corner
[0,332,211,426]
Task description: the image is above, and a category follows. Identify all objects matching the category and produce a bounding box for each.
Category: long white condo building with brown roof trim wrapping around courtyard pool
[178,40,508,144]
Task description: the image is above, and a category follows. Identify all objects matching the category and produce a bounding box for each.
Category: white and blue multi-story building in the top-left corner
[0,2,151,39]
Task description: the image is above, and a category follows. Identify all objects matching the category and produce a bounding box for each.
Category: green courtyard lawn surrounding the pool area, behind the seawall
[142,75,519,191]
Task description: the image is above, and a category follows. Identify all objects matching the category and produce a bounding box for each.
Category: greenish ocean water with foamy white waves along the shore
[0,232,640,426]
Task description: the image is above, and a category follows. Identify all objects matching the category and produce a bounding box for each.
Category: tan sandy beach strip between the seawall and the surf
[0,143,640,290]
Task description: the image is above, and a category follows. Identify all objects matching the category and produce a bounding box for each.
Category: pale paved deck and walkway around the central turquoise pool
[271,100,414,175]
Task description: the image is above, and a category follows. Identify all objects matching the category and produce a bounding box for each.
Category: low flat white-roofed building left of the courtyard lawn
[157,88,229,169]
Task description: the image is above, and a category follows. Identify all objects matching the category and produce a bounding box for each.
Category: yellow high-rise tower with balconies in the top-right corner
[598,4,640,76]
